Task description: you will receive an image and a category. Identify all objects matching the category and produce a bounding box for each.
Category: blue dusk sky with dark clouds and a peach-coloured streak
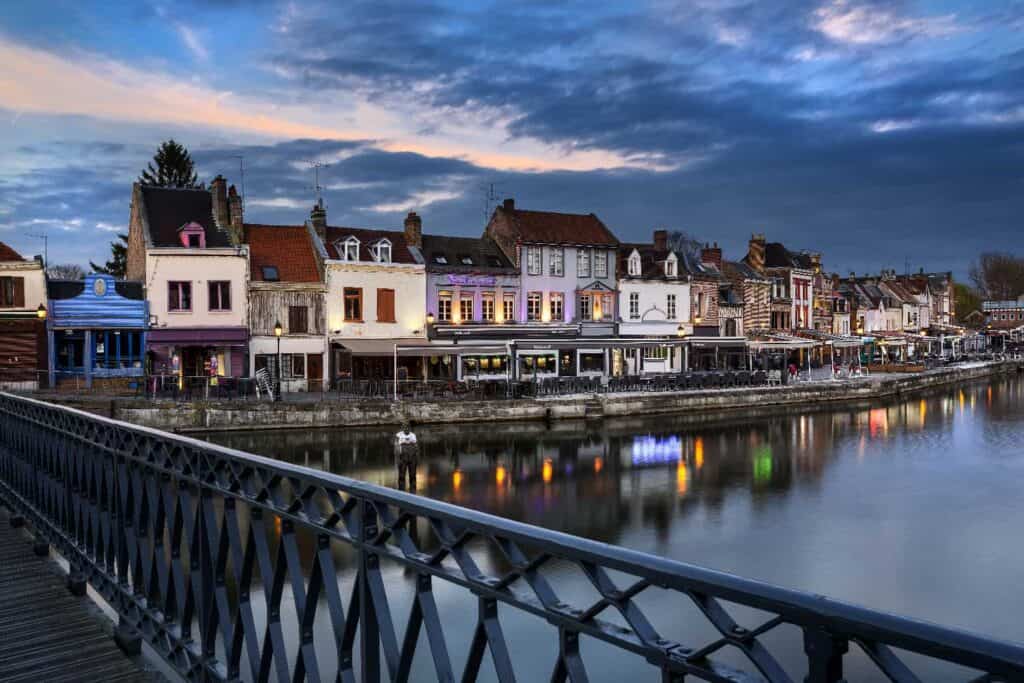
[0,0,1024,276]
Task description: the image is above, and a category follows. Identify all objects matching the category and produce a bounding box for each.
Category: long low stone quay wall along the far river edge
[36,361,1024,432]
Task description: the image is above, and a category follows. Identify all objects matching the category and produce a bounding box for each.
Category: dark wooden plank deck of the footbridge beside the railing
[0,508,161,683]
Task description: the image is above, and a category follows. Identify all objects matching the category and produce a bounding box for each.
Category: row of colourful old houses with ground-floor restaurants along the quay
[0,176,953,390]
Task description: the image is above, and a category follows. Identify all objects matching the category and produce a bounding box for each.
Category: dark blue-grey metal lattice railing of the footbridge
[0,394,1024,682]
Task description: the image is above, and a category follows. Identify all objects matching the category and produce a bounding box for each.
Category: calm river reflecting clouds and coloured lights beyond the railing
[206,377,1024,680]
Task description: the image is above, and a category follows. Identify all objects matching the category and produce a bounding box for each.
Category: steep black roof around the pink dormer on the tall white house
[136,185,231,247]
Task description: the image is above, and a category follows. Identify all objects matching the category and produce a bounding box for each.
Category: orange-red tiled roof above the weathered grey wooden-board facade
[245,223,321,283]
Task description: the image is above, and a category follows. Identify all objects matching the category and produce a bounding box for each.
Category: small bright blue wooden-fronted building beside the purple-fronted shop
[46,273,150,386]
